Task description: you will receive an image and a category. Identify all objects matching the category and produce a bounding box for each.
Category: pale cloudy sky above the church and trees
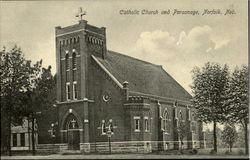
[0,0,248,93]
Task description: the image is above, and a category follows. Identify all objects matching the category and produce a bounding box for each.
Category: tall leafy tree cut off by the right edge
[227,66,249,154]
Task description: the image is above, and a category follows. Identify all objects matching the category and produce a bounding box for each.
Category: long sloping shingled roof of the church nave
[96,51,191,101]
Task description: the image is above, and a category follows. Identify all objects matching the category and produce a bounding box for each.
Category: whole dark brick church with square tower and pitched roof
[37,16,205,153]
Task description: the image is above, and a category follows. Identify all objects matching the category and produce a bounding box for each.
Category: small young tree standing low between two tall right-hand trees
[221,124,238,152]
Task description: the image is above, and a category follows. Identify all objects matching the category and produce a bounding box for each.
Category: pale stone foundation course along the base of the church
[37,141,205,154]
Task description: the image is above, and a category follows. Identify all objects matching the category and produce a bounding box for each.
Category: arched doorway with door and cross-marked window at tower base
[64,114,80,150]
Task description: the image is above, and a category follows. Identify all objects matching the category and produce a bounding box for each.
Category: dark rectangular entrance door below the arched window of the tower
[68,130,80,150]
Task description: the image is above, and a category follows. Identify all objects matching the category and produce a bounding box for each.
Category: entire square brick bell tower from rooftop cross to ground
[55,9,106,152]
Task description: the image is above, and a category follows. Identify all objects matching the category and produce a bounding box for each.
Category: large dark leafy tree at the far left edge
[0,46,42,155]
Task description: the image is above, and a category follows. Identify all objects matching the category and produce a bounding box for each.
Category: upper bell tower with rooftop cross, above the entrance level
[55,9,107,102]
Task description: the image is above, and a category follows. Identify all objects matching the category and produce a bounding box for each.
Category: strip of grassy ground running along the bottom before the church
[1,148,249,159]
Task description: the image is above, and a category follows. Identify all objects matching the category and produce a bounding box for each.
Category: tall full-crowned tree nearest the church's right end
[191,62,229,152]
